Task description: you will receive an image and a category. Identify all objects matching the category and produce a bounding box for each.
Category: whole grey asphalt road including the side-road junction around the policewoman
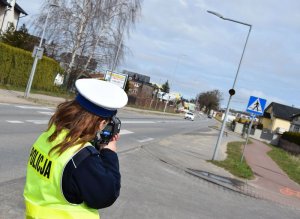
[0,104,300,219]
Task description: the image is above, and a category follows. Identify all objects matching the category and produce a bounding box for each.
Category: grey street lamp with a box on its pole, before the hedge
[24,4,59,98]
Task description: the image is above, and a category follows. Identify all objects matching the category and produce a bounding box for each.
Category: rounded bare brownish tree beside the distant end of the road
[196,90,222,112]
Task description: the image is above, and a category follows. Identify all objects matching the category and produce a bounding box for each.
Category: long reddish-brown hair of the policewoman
[48,100,105,155]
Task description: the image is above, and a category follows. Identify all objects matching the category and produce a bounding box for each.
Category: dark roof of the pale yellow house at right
[264,102,300,121]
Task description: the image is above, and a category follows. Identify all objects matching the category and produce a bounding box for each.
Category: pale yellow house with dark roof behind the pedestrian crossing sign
[260,102,300,134]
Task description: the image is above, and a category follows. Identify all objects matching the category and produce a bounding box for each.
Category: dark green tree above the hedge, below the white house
[0,23,39,51]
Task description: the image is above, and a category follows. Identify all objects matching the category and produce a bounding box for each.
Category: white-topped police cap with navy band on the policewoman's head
[75,78,128,118]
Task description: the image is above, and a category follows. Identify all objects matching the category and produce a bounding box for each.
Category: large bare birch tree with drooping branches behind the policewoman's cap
[33,0,141,87]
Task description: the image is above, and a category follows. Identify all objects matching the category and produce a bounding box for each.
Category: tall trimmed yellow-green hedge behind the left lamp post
[0,42,62,91]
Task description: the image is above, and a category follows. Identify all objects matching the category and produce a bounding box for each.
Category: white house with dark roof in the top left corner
[0,0,27,33]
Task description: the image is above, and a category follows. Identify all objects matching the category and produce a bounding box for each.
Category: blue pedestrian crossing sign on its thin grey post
[241,96,267,163]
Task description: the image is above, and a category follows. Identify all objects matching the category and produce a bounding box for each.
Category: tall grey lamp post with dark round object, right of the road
[207,11,252,160]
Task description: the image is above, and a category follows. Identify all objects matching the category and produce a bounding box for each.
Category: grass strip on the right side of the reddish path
[267,144,300,185]
